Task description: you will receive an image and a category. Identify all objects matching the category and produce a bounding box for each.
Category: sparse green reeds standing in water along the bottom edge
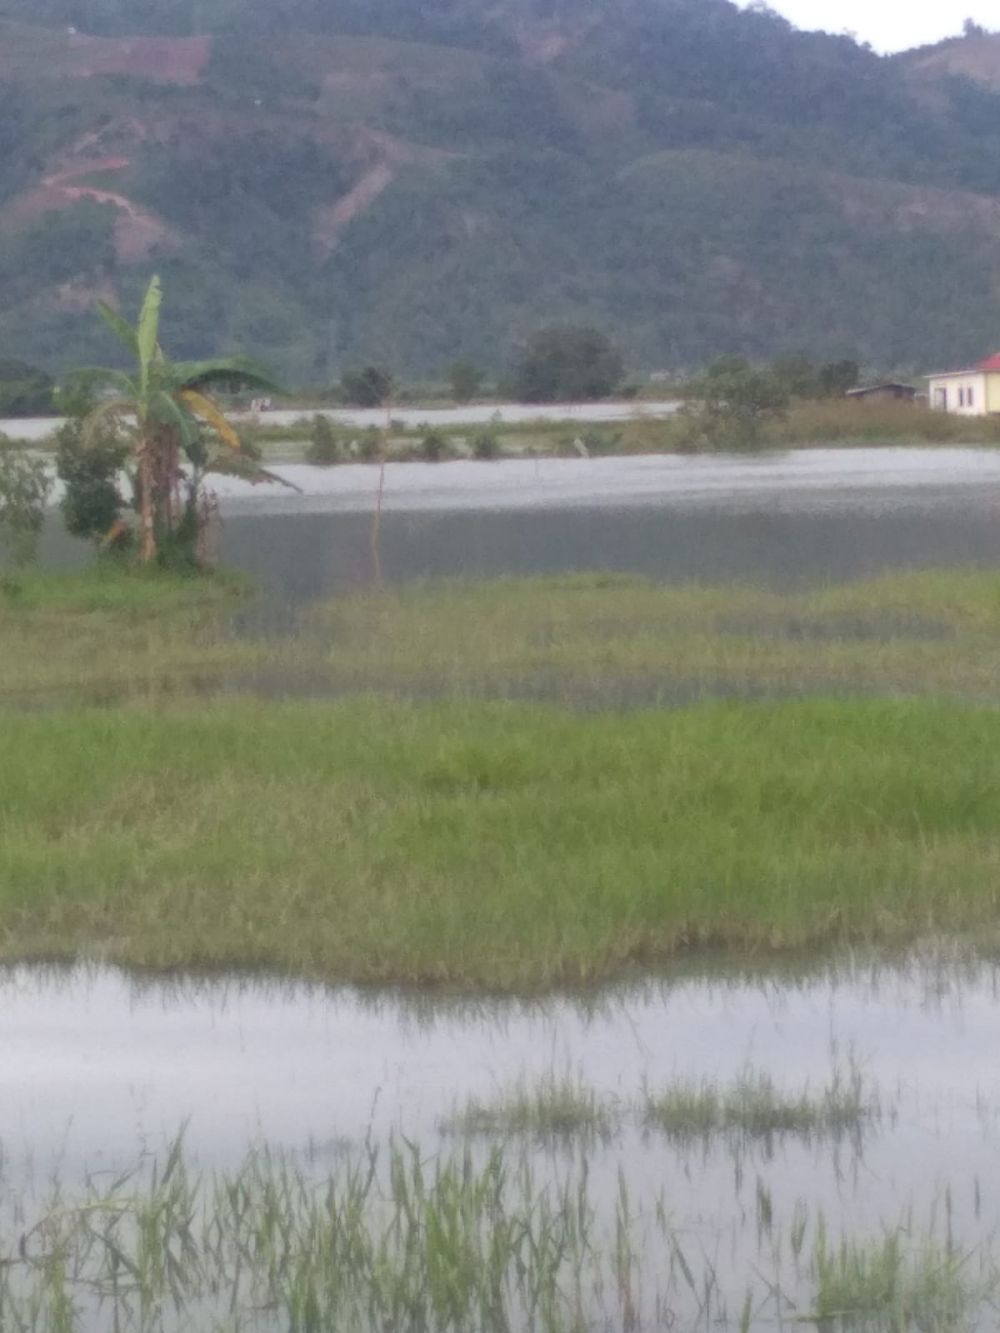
[0,1140,1000,1333]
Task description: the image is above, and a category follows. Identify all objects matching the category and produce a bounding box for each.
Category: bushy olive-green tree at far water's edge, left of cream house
[685,357,789,449]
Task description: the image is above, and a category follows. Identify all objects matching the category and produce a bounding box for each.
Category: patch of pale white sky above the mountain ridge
[741,0,1000,51]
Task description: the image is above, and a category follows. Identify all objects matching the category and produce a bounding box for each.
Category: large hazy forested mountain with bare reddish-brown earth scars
[0,0,1000,383]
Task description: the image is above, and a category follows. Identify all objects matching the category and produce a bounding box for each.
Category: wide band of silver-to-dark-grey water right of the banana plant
[212,449,1000,601]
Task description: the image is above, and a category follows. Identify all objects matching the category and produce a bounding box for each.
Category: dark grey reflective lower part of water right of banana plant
[223,503,1000,601]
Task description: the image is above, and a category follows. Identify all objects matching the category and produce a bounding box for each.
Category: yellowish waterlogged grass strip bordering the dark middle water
[300,569,1000,708]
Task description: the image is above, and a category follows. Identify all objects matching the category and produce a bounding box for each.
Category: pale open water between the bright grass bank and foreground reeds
[0,956,1000,1322]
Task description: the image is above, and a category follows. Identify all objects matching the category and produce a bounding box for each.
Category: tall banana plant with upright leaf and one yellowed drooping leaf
[84,277,280,564]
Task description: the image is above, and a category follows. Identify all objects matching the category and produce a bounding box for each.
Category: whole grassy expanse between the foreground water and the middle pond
[0,573,1000,989]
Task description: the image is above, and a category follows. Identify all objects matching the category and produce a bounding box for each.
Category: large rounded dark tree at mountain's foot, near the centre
[511,324,625,403]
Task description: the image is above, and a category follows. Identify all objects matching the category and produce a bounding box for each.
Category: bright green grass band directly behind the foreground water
[0,696,1000,990]
